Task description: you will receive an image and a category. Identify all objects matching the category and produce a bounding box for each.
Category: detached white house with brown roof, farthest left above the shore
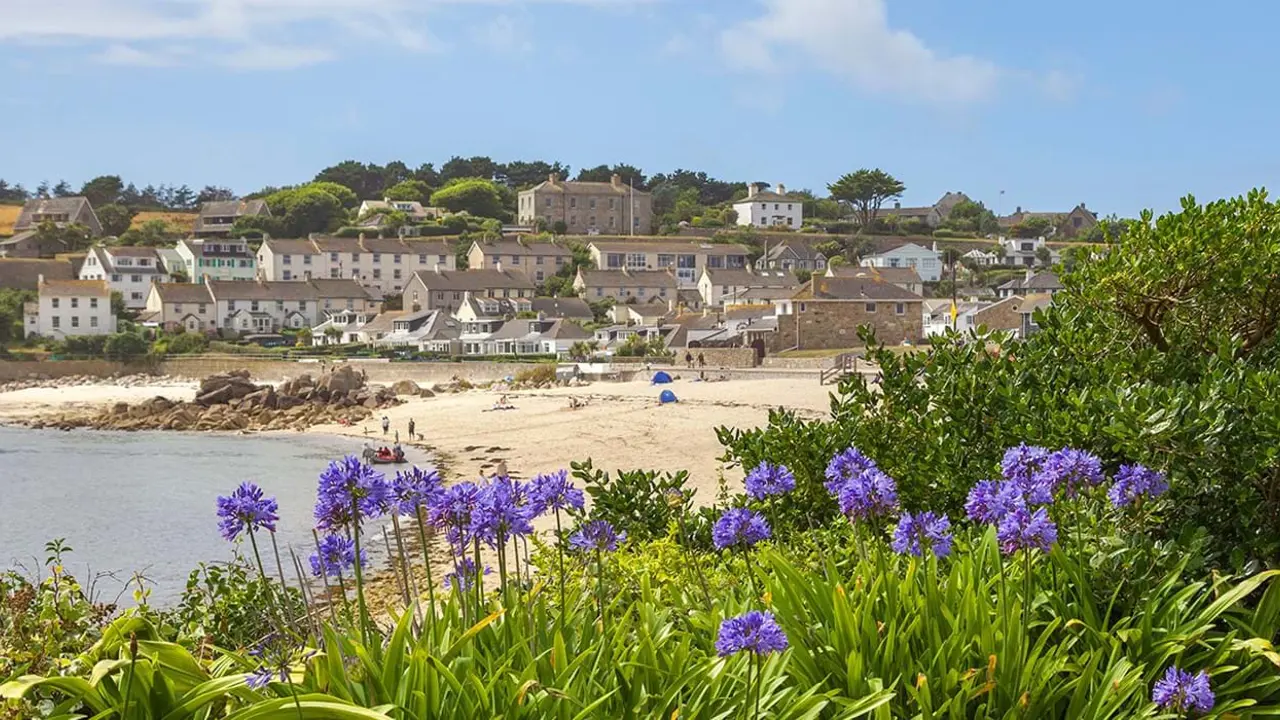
[22,275,115,340]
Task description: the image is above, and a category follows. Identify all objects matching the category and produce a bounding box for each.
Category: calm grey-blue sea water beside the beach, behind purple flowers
[0,427,426,605]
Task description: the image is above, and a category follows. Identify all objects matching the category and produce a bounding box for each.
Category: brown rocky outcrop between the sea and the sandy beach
[29,366,401,430]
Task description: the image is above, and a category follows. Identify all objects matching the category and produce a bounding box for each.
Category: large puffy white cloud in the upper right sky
[721,0,1004,104]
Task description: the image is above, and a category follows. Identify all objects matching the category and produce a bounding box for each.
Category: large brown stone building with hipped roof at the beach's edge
[772,275,924,351]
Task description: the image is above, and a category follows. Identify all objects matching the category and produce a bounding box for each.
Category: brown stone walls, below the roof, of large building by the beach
[771,300,924,351]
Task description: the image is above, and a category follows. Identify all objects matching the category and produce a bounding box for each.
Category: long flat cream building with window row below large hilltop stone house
[586,241,750,290]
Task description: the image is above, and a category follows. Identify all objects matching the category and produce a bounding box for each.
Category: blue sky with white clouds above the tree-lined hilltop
[0,0,1280,215]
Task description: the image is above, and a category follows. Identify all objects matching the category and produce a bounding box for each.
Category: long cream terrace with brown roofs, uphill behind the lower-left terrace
[257,234,457,295]
